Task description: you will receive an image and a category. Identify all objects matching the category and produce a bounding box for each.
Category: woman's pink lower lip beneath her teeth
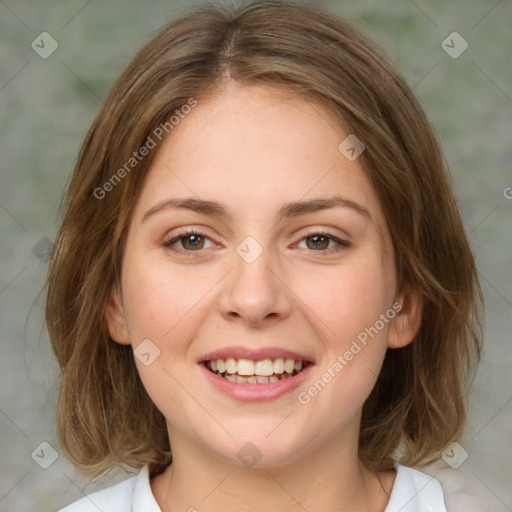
[199,363,314,402]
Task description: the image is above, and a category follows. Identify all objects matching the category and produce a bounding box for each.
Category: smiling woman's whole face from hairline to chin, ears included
[107,85,413,466]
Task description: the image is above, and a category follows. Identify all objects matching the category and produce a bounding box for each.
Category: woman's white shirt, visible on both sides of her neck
[58,464,446,512]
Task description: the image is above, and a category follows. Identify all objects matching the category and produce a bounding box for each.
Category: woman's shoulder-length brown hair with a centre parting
[46,1,482,477]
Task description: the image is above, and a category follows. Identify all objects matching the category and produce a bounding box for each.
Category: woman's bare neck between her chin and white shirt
[151,431,394,512]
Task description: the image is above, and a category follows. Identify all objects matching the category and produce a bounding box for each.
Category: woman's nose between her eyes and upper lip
[220,244,293,327]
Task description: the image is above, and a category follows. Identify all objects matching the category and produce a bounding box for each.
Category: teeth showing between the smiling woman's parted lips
[203,357,312,384]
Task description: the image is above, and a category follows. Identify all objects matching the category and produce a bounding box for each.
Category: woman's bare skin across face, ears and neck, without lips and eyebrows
[106,83,420,512]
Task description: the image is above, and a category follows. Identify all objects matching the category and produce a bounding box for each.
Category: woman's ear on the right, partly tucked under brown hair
[388,289,422,348]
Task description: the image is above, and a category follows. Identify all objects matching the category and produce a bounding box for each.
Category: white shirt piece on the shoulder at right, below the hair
[385,464,446,512]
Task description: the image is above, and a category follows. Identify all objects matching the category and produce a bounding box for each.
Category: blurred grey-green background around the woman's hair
[0,0,512,512]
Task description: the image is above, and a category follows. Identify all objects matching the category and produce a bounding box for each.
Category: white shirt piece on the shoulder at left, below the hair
[58,466,161,512]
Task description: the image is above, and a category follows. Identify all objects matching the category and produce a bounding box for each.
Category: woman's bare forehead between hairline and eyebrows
[137,85,385,248]
